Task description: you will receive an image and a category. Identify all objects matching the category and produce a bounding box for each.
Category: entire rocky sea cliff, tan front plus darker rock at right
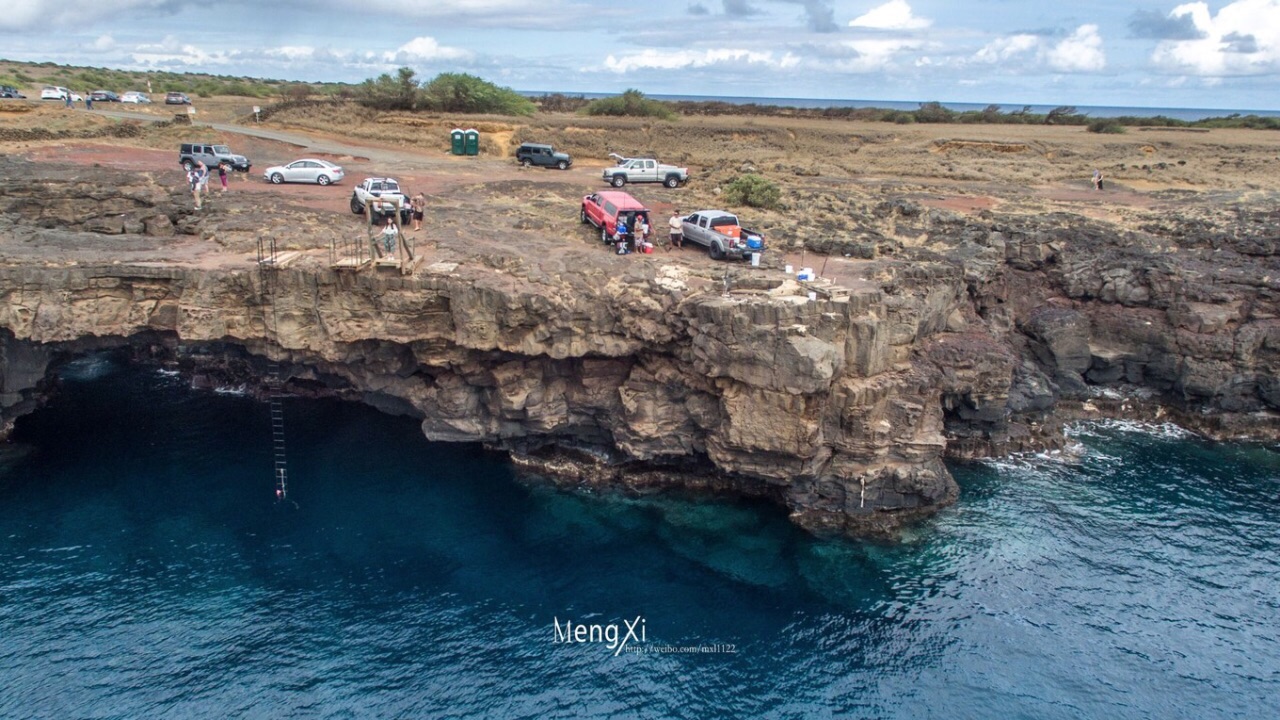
[0,159,1280,533]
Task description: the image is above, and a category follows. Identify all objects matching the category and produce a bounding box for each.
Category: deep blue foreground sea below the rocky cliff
[0,357,1280,720]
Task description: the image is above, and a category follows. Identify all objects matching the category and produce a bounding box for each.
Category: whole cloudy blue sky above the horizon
[0,0,1280,110]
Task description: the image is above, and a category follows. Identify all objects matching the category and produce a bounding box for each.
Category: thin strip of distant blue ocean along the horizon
[524,91,1280,122]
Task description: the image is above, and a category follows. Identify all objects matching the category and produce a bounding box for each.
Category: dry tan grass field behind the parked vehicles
[0,97,1280,266]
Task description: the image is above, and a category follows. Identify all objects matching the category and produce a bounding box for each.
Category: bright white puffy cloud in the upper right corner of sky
[1151,0,1280,77]
